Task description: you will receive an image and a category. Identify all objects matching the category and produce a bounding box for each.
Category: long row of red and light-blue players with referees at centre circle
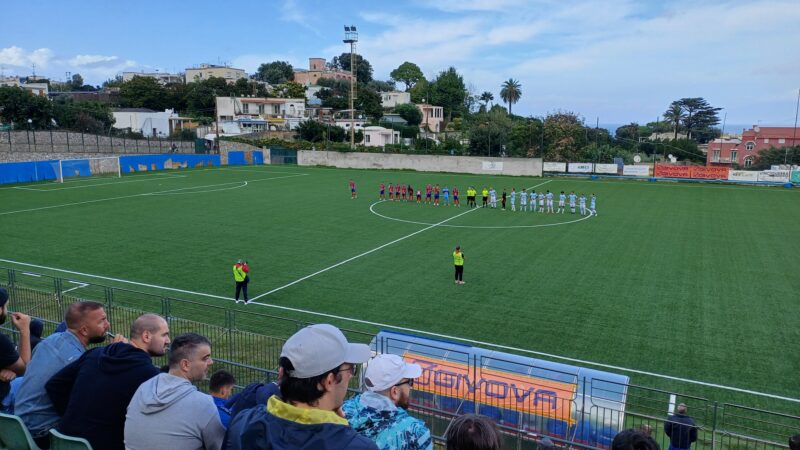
[379,183,597,216]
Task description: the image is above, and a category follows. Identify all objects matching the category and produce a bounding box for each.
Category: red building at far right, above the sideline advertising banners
[706,125,800,168]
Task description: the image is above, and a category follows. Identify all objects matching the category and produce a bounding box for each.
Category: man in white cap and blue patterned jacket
[342,354,433,450]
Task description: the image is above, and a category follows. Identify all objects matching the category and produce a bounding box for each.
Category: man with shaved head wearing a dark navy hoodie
[45,314,169,450]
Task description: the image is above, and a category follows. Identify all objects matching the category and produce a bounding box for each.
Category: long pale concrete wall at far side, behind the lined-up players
[297,150,542,177]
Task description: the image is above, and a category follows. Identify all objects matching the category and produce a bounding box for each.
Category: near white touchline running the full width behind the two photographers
[0,256,800,403]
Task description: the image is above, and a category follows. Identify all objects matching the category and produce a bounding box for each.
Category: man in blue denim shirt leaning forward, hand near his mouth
[15,302,114,448]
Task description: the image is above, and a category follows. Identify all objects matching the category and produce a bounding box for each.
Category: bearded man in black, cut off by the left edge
[0,288,31,400]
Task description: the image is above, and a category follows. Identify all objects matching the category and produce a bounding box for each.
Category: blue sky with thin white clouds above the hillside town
[0,0,800,131]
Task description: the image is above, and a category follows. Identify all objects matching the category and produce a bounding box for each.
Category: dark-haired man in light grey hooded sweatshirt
[125,333,225,450]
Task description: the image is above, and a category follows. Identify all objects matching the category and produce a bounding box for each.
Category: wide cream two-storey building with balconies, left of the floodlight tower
[216,97,306,132]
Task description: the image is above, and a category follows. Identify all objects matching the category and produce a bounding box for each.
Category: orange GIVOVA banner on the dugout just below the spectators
[403,353,576,424]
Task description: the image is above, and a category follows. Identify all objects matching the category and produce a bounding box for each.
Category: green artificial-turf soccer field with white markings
[0,166,800,412]
